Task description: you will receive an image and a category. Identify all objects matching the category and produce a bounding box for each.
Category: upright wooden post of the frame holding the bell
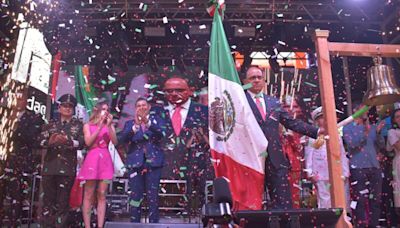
[314,30,352,227]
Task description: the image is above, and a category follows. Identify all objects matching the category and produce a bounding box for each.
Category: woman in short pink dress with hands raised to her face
[78,103,117,228]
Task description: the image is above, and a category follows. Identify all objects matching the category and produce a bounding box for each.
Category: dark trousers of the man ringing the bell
[265,159,293,209]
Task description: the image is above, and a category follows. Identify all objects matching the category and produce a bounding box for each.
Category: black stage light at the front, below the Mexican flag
[202,177,233,227]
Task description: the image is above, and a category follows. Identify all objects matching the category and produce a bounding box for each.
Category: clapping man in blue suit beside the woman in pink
[118,98,165,223]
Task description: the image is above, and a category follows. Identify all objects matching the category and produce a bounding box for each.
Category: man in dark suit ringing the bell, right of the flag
[244,67,323,209]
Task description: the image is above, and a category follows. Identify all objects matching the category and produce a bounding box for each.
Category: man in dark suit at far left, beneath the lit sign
[0,90,44,226]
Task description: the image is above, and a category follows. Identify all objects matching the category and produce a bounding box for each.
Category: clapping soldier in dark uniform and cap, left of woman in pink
[39,94,84,227]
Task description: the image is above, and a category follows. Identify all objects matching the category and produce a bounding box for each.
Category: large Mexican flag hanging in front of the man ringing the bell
[208,5,268,210]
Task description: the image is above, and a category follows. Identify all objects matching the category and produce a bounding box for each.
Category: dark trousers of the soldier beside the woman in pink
[41,175,75,227]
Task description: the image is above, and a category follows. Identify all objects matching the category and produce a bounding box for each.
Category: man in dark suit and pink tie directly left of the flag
[154,77,211,217]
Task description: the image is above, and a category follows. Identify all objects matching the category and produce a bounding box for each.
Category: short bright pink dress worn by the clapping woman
[77,124,114,180]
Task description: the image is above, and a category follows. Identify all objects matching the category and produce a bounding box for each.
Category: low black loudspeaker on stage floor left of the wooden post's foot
[234,208,343,228]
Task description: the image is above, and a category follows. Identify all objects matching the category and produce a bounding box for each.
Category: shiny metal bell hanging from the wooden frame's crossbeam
[363,56,400,106]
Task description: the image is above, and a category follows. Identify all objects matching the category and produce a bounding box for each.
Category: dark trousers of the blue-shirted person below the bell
[350,168,382,227]
